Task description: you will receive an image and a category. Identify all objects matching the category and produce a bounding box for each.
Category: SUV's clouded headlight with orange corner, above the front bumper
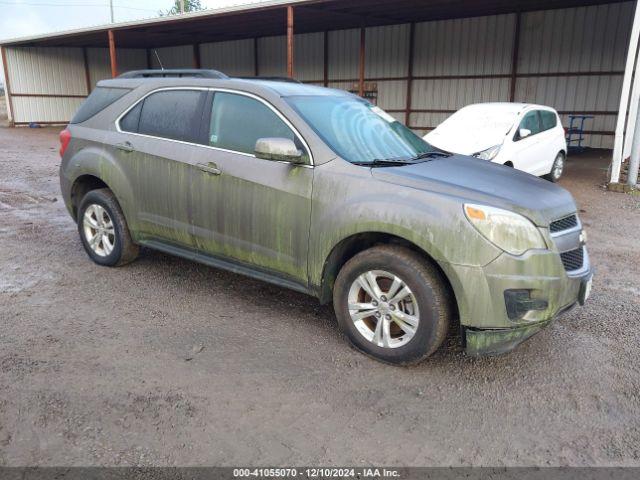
[464,203,547,255]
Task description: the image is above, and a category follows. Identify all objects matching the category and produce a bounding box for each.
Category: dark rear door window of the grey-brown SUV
[136,90,207,143]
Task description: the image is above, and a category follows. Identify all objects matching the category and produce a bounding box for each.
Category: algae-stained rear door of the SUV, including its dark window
[114,89,208,247]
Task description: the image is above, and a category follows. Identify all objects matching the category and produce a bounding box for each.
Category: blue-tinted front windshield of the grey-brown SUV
[286,95,437,163]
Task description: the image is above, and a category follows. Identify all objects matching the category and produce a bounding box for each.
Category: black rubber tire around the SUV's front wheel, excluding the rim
[333,245,452,364]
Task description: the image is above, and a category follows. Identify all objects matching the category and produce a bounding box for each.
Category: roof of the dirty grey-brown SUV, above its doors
[97,77,352,97]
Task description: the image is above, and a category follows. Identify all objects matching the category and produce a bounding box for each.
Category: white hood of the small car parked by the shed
[424,128,508,155]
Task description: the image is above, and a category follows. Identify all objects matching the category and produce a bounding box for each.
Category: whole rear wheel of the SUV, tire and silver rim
[78,188,139,267]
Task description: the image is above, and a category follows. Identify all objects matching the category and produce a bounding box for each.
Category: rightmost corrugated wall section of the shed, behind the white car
[515,2,634,148]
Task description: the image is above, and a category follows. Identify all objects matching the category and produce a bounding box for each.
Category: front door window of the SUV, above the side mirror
[209,92,304,160]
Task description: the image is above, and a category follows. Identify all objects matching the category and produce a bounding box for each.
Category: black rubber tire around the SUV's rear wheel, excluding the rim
[77,188,139,267]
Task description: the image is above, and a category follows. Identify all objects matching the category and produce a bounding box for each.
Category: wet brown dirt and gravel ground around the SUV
[0,125,640,466]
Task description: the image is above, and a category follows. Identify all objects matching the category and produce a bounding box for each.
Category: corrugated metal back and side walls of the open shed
[2,1,634,148]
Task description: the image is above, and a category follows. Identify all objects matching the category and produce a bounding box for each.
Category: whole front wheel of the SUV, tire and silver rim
[333,246,451,364]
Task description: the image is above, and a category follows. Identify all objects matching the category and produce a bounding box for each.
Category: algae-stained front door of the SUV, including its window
[191,92,313,285]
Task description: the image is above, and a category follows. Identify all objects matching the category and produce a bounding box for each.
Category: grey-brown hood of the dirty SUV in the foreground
[372,155,576,227]
